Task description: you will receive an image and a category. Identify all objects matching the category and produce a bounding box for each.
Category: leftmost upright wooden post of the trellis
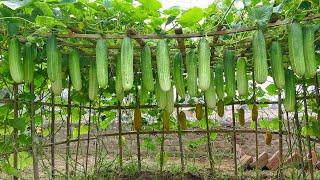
[13,84,19,180]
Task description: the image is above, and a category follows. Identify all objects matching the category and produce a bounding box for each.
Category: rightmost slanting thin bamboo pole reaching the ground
[302,82,314,180]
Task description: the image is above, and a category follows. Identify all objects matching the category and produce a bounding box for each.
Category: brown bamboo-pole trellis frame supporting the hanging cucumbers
[0,14,320,179]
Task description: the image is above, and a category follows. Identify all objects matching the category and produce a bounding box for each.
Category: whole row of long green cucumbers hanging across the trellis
[9,23,318,129]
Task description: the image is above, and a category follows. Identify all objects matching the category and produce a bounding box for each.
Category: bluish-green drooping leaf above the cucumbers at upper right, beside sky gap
[249,6,273,29]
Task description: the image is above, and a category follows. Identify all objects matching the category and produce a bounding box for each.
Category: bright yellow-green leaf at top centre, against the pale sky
[179,7,204,27]
